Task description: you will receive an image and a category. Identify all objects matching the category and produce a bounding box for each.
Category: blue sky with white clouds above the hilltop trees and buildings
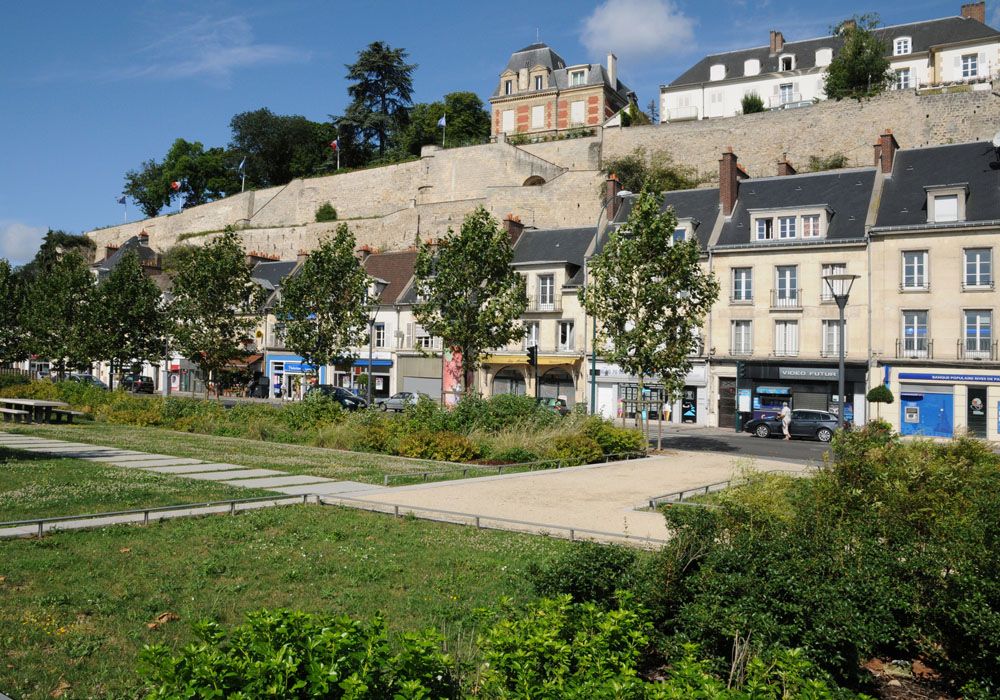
[0,0,984,263]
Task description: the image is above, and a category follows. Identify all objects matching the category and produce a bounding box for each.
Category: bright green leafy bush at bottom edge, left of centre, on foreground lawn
[141,610,459,700]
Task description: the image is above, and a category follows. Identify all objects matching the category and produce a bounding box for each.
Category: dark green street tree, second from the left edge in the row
[21,251,97,377]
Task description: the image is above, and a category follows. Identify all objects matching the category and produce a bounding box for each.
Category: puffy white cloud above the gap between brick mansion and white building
[580,0,695,60]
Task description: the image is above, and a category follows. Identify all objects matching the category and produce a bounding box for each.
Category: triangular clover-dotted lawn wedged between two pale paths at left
[0,447,271,522]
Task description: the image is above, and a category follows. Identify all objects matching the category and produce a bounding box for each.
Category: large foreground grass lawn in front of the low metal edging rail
[0,506,569,700]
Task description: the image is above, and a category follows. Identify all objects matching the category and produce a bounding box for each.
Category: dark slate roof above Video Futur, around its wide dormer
[718,168,875,247]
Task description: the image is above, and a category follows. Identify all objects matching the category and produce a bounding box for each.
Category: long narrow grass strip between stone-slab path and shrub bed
[3,423,442,484]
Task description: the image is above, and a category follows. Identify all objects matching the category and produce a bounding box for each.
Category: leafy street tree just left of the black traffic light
[413,207,528,392]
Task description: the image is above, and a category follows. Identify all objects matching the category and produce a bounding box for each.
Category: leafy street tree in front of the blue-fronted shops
[275,224,370,374]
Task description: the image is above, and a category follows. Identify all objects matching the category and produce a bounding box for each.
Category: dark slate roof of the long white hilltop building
[666,17,1000,88]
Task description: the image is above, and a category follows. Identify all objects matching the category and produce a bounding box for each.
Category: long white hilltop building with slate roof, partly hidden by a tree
[660,2,1000,122]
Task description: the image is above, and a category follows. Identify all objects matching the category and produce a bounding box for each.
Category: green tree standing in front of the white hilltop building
[823,14,892,100]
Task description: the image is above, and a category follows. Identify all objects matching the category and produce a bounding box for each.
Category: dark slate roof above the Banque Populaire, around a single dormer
[875,142,1000,229]
